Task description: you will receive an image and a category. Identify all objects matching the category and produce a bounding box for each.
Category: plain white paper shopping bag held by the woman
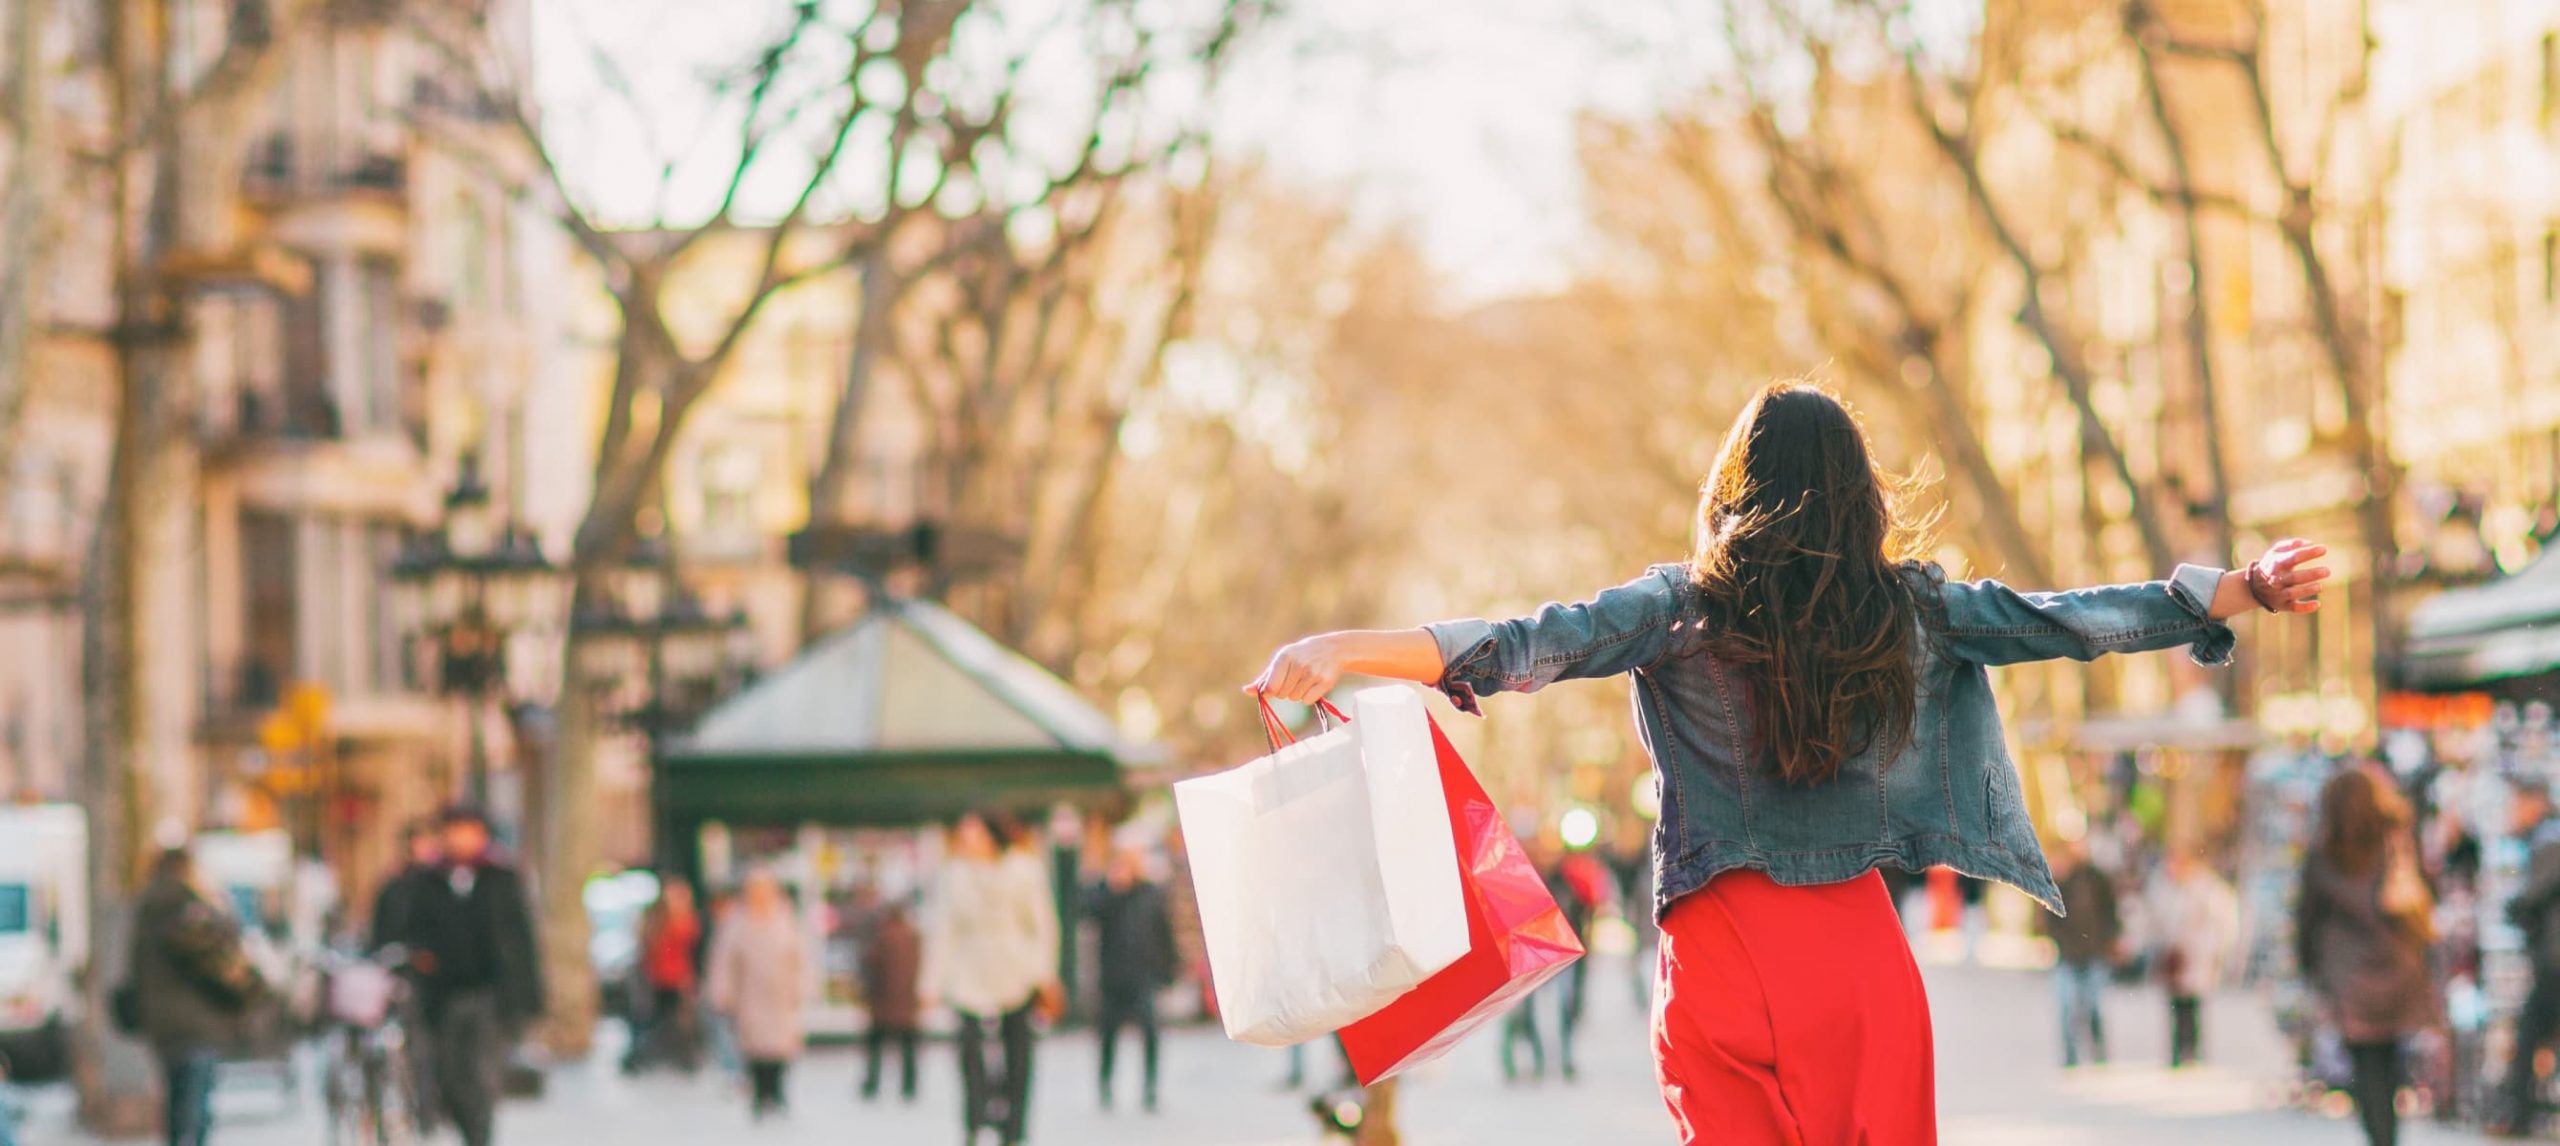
[1172,686,1467,1046]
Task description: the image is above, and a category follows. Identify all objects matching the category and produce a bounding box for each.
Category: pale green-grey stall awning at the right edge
[2399,550,2560,688]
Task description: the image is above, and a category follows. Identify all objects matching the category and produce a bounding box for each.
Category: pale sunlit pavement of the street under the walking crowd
[23,962,2481,1146]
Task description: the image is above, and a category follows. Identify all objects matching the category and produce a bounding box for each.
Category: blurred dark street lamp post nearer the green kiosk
[571,537,755,872]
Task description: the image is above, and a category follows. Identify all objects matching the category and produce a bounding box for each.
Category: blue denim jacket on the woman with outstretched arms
[1426,565,2232,916]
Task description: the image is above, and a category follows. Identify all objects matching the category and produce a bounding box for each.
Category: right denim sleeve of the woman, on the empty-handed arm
[1933,565,2232,665]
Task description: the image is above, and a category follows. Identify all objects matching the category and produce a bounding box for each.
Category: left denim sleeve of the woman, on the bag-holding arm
[1423,565,1687,716]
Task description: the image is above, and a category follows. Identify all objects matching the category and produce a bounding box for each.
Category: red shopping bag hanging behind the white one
[1341,721,1582,1085]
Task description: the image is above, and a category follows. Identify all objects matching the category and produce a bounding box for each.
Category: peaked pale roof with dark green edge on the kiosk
[658,599,1157,826]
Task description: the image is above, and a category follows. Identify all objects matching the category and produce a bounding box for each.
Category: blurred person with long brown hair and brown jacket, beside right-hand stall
[2294,762,2437,1146]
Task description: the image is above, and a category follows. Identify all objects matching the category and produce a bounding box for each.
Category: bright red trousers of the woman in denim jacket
[1654,872,1938,1146]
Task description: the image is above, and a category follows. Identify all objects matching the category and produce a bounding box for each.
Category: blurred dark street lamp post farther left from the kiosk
[392,453,561,803]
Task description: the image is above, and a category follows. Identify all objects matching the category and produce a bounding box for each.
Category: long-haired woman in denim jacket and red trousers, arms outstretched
[1247,384,2327,1143]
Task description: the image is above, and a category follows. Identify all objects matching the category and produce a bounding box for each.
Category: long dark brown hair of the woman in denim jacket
[1690,381,1923,785]
